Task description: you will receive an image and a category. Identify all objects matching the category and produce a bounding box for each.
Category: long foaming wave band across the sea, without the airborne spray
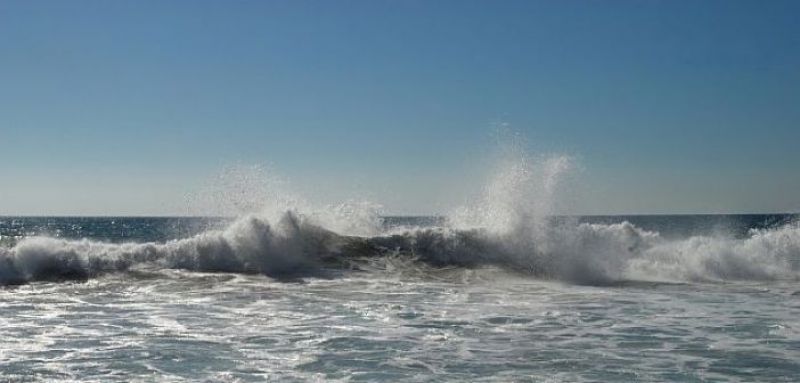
[0,212,800,285]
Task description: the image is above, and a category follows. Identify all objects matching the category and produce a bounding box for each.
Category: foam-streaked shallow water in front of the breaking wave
[0,269,800,382]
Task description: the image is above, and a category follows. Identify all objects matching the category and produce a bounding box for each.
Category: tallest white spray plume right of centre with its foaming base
[415,142,644,283]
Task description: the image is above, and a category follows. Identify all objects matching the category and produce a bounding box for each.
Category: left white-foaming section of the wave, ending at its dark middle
[0,212,354,284]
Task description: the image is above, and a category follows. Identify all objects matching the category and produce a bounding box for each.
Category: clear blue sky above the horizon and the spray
[0,0,800,215]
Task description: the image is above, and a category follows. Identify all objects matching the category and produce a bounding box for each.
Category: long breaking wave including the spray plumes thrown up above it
[0,146,800,285]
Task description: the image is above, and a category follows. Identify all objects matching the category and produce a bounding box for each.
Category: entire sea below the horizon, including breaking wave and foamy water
[0,212,800,382]
